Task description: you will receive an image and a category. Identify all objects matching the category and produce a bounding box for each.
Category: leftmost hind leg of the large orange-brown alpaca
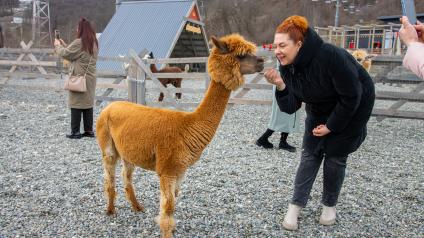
[103,155,118,215]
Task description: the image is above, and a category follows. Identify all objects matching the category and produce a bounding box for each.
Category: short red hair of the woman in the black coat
[275,16,308,42]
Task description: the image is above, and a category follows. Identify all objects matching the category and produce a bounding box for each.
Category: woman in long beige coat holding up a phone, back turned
[54,17,98,139]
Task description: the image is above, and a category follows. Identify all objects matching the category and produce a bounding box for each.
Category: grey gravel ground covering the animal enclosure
[0,77,424,237]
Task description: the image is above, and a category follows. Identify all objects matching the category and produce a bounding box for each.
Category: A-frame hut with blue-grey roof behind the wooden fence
[97,0,209,72]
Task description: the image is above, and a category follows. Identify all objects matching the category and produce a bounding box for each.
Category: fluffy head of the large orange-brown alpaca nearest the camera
[208,34,264,90]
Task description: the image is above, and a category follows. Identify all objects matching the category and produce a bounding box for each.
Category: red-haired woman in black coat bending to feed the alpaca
[264,16,375,230]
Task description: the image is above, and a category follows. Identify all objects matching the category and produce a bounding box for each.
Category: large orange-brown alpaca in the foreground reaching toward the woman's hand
[97,34,264,237]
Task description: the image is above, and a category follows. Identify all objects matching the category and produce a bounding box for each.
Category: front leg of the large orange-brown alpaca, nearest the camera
[157,175,177,238]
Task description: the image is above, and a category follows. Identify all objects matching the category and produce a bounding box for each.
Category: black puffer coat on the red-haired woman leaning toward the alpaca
[275,28,375,156]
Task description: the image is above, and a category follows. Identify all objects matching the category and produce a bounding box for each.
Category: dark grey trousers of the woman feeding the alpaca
[291,150,347,207]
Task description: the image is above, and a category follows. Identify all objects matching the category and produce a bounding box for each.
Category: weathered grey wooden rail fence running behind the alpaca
[0,44,424,120]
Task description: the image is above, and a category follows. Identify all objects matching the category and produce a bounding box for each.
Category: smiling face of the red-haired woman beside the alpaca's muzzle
[274,33,302,65]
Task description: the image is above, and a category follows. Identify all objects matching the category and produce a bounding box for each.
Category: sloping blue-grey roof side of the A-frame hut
[97,0,193,72]
